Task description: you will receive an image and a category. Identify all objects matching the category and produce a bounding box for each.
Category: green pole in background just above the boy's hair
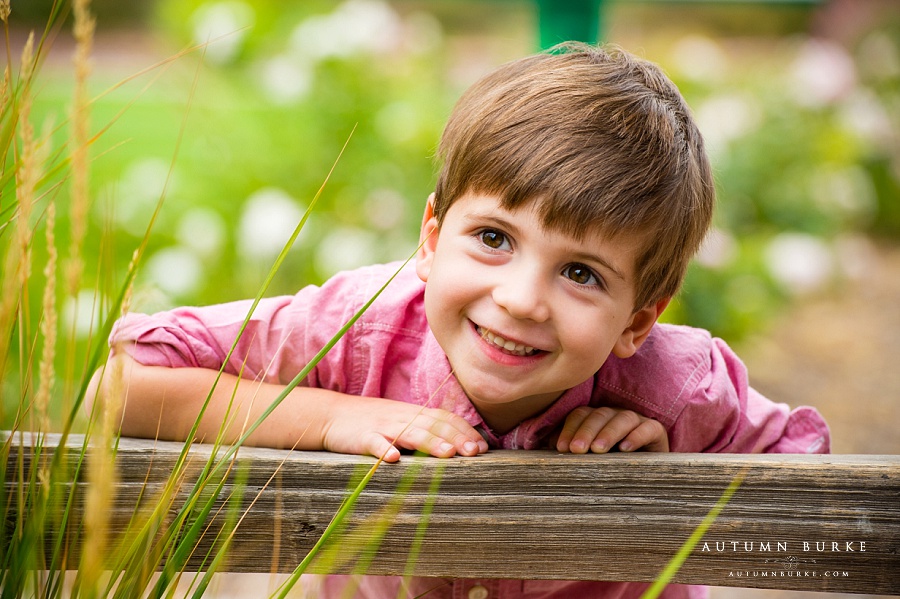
[537,0,604,50]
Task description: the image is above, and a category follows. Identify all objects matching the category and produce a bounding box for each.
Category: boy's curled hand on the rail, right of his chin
[556,406,669,453]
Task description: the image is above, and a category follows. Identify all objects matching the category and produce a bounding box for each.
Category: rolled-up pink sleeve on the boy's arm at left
[109,268,366,390]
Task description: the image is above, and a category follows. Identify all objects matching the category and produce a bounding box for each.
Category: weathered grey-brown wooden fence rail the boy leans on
[3,436,900,594]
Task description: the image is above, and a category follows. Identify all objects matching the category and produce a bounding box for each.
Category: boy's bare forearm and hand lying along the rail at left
[88,351,487,462]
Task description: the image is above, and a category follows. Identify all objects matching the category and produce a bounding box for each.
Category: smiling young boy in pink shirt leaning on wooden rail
[94,45,829,597]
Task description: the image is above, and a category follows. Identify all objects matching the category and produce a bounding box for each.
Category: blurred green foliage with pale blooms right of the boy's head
[668,17,900,339]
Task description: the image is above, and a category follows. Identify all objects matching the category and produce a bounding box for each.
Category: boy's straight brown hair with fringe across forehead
[434,44,715,309]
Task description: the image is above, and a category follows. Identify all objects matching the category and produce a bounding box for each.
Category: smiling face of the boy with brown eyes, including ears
[416,193,667,431]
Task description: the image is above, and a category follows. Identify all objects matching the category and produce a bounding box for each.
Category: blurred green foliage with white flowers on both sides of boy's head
[17,0,900,346]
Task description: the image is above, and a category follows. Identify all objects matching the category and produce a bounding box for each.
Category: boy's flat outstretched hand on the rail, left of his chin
[322,396,488,462]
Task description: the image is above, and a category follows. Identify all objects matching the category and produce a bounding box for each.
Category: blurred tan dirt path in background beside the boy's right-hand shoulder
[710,240,900,599]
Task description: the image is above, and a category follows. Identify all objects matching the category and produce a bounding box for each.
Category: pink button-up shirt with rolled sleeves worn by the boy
[110,263,829,599]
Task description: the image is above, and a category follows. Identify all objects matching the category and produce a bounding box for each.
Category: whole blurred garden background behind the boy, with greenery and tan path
[0,0,900,596]
